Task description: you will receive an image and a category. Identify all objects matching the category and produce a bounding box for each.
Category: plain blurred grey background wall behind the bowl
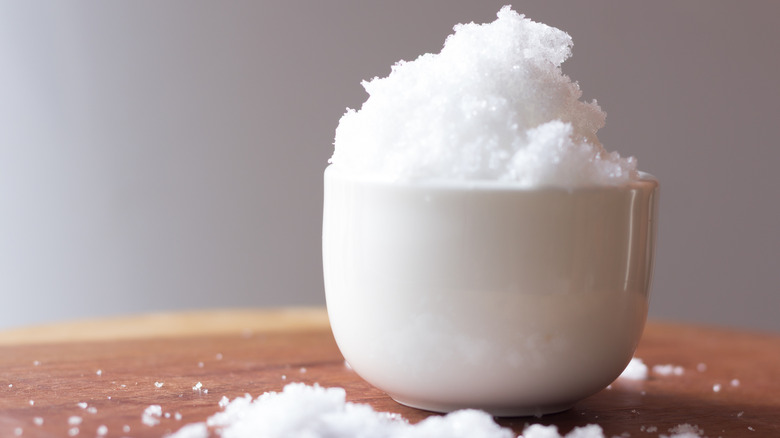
[0,0,780,331]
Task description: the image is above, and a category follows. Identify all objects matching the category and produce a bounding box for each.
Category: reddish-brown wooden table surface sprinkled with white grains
[0,309,780,438]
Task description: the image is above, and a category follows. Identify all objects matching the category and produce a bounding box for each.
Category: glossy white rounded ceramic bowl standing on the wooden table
[323,166,658,416]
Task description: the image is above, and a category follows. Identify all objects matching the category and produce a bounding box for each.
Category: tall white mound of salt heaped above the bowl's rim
[331,6,638,187]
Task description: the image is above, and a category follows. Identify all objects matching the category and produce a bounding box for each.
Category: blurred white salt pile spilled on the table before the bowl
[170,383,604,438]
